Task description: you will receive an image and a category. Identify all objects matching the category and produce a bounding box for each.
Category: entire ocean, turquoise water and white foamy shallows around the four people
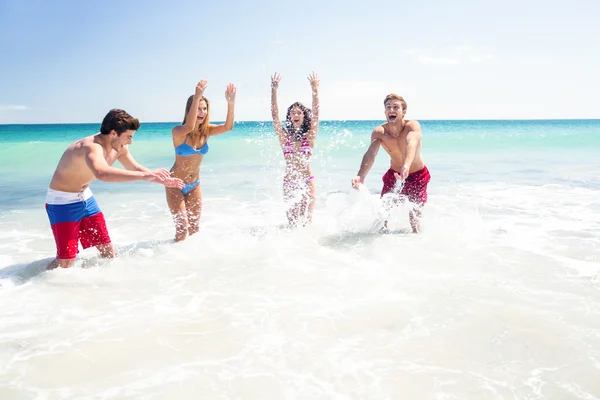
[0,120,600,400]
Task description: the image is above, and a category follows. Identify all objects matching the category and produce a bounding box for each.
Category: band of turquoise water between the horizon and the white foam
[0,120,600,209]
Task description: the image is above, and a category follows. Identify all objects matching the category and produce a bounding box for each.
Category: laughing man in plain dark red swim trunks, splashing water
[352,93,430,233]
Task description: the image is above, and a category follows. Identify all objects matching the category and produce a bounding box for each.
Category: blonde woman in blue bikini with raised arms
[167,80,235,242]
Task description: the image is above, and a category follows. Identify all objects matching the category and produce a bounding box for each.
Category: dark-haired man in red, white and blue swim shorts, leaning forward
[46,109,183,269]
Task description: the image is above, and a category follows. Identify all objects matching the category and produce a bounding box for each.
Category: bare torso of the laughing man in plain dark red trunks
[378,121,425,174]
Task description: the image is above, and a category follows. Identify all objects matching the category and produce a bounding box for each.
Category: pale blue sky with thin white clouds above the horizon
[0,0,600,124]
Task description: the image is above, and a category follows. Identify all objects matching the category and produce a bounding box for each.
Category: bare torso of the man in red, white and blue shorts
[50,135,120,193]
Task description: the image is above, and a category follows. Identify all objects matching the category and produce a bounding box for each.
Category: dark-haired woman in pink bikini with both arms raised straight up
[271,72,319,226]
